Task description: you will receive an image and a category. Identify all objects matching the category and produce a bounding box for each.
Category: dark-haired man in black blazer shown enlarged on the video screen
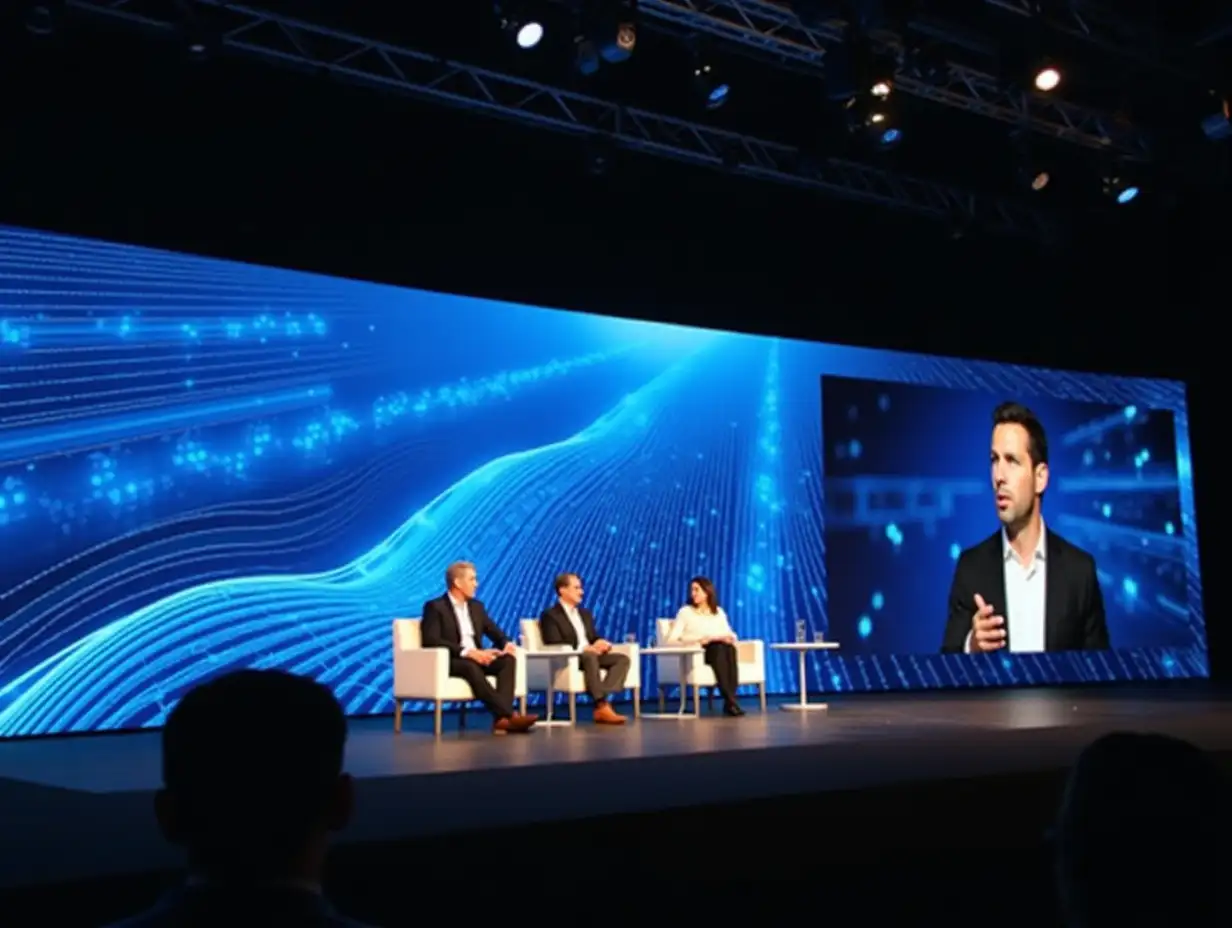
[941,403,1110,653]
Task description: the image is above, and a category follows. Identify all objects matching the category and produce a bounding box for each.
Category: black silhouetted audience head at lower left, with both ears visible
[155,670,352,881]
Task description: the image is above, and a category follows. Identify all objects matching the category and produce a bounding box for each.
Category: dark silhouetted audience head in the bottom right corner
[1056,732,1228,928]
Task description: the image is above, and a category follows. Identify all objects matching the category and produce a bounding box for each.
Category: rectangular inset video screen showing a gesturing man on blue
[822,376,1204,672]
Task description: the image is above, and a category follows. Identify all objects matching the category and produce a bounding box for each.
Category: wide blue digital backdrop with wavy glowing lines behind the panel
[0,229,1206,737]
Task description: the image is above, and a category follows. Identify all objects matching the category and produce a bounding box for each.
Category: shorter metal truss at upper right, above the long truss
[638,0,1149,160]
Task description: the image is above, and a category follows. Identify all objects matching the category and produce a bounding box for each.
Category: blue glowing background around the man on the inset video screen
[822,377,1206,684]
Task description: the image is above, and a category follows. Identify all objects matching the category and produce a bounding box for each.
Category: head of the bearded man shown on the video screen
[988,403,1048,530]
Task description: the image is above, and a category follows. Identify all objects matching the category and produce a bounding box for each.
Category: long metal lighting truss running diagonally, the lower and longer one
[68,0,1050,237]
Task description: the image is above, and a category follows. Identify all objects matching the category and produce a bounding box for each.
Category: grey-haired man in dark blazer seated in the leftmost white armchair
[419,561,538,735]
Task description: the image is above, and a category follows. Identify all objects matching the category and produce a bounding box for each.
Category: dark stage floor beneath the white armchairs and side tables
[0,689,1232,886]
